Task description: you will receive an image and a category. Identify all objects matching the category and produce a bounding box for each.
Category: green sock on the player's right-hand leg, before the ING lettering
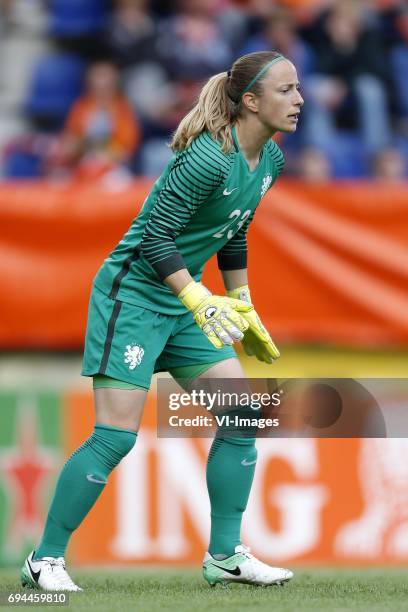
[207,437,257,558]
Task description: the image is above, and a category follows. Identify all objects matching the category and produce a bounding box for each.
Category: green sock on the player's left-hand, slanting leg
[34,424,137,560]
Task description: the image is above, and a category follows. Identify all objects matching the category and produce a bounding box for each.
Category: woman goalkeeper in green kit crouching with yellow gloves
[22,52,303,590]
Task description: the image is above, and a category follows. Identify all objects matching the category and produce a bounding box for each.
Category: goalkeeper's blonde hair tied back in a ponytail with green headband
[170,51,280,153]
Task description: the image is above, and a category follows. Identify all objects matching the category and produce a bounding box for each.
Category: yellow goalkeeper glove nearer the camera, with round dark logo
[177,281,253,348]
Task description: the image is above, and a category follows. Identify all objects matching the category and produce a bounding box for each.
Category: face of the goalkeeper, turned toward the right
[256,60,303,132]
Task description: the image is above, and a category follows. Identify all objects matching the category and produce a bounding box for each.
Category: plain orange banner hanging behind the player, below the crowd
[0,180,408,349]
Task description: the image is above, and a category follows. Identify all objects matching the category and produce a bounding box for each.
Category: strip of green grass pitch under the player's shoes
[0,567,408,612]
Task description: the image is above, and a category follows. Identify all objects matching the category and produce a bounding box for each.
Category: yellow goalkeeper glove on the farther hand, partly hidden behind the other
[227,285,280,363]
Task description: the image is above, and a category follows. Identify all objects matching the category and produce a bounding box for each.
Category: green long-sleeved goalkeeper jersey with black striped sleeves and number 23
[94,129,284,315]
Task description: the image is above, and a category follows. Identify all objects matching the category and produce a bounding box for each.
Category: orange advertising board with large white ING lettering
[64,392,408,565]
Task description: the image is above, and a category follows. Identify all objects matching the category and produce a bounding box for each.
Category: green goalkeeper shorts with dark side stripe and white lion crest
[82,287,236,389]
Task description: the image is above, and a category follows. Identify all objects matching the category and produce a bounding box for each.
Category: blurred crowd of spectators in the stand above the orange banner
[0,0,408,182]
